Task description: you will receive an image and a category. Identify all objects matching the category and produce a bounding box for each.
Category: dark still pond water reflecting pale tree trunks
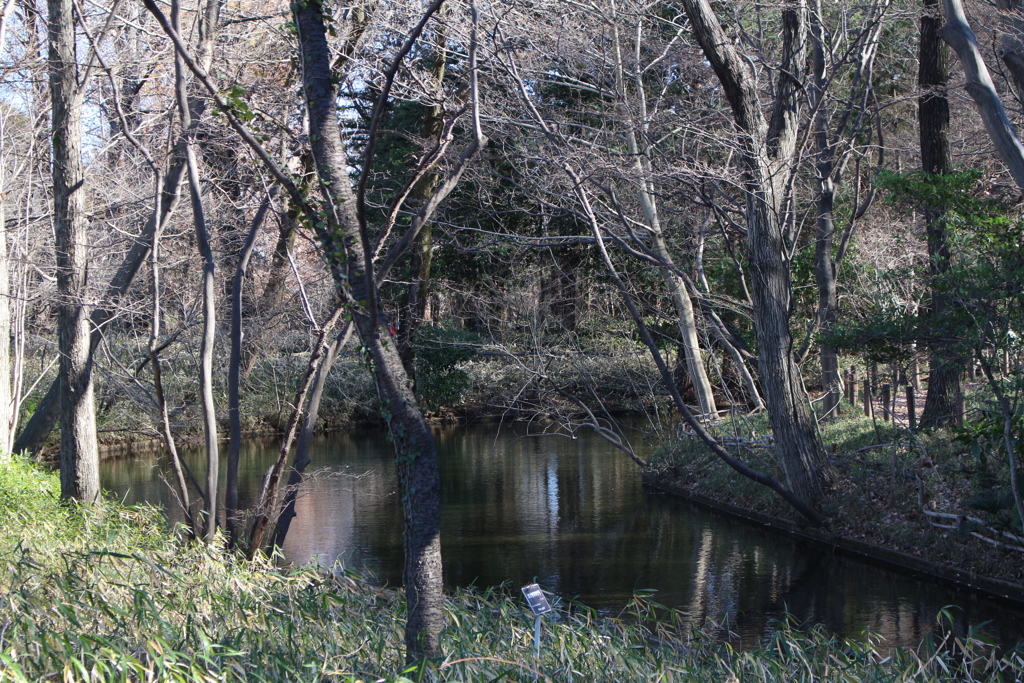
[102,425,1024,646]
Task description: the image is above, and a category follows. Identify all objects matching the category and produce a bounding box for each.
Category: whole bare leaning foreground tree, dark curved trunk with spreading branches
[144,0,486,659]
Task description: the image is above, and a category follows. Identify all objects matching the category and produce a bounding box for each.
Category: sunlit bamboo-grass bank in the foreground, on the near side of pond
[0,457,1024,683]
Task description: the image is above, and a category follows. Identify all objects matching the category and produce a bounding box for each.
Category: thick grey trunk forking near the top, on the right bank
[683,0,827,503]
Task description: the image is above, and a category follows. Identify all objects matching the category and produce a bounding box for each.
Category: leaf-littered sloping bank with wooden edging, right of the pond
[645,409,1024,603]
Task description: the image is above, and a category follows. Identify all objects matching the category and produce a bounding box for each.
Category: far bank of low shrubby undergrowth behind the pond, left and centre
[18,338,656,458]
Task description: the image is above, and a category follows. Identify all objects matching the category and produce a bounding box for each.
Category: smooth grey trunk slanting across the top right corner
[942,0,1024,190]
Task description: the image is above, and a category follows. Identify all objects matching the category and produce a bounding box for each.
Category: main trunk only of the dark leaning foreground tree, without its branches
[292,0,444,659]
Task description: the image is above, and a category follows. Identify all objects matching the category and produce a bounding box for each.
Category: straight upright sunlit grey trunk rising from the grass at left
[48,0,99,503]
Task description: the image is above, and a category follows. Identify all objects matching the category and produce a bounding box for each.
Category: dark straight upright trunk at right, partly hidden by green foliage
[918,0,962,427]
